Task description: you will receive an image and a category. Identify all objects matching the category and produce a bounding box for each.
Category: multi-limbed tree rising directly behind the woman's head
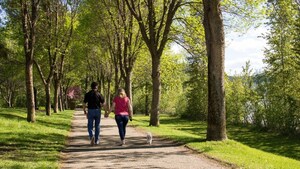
[102,0,142,99]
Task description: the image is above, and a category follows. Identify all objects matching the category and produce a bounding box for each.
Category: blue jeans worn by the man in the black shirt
[88,109,101,143]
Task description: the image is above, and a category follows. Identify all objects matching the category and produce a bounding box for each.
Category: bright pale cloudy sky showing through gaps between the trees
[171,26,267,75]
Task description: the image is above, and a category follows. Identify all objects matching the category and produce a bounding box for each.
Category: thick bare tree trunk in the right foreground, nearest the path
[203,0,227,141]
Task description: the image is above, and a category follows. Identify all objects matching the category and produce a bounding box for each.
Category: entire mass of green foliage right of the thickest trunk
[226,1,300,134]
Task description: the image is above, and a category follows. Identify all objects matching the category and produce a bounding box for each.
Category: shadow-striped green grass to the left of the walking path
[0,108,73,169]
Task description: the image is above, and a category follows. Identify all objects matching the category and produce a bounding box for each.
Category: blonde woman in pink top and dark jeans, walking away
[106,88,132,146]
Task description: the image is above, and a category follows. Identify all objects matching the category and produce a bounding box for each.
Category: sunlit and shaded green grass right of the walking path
[132,116,300,169]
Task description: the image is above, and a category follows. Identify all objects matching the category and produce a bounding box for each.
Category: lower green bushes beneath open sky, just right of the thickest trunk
[226,62,260,124]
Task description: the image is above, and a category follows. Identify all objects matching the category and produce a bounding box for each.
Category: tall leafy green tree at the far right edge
[265,1,300,133]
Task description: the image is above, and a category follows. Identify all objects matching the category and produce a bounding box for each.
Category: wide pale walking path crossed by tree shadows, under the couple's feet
[60,111,228,169]
